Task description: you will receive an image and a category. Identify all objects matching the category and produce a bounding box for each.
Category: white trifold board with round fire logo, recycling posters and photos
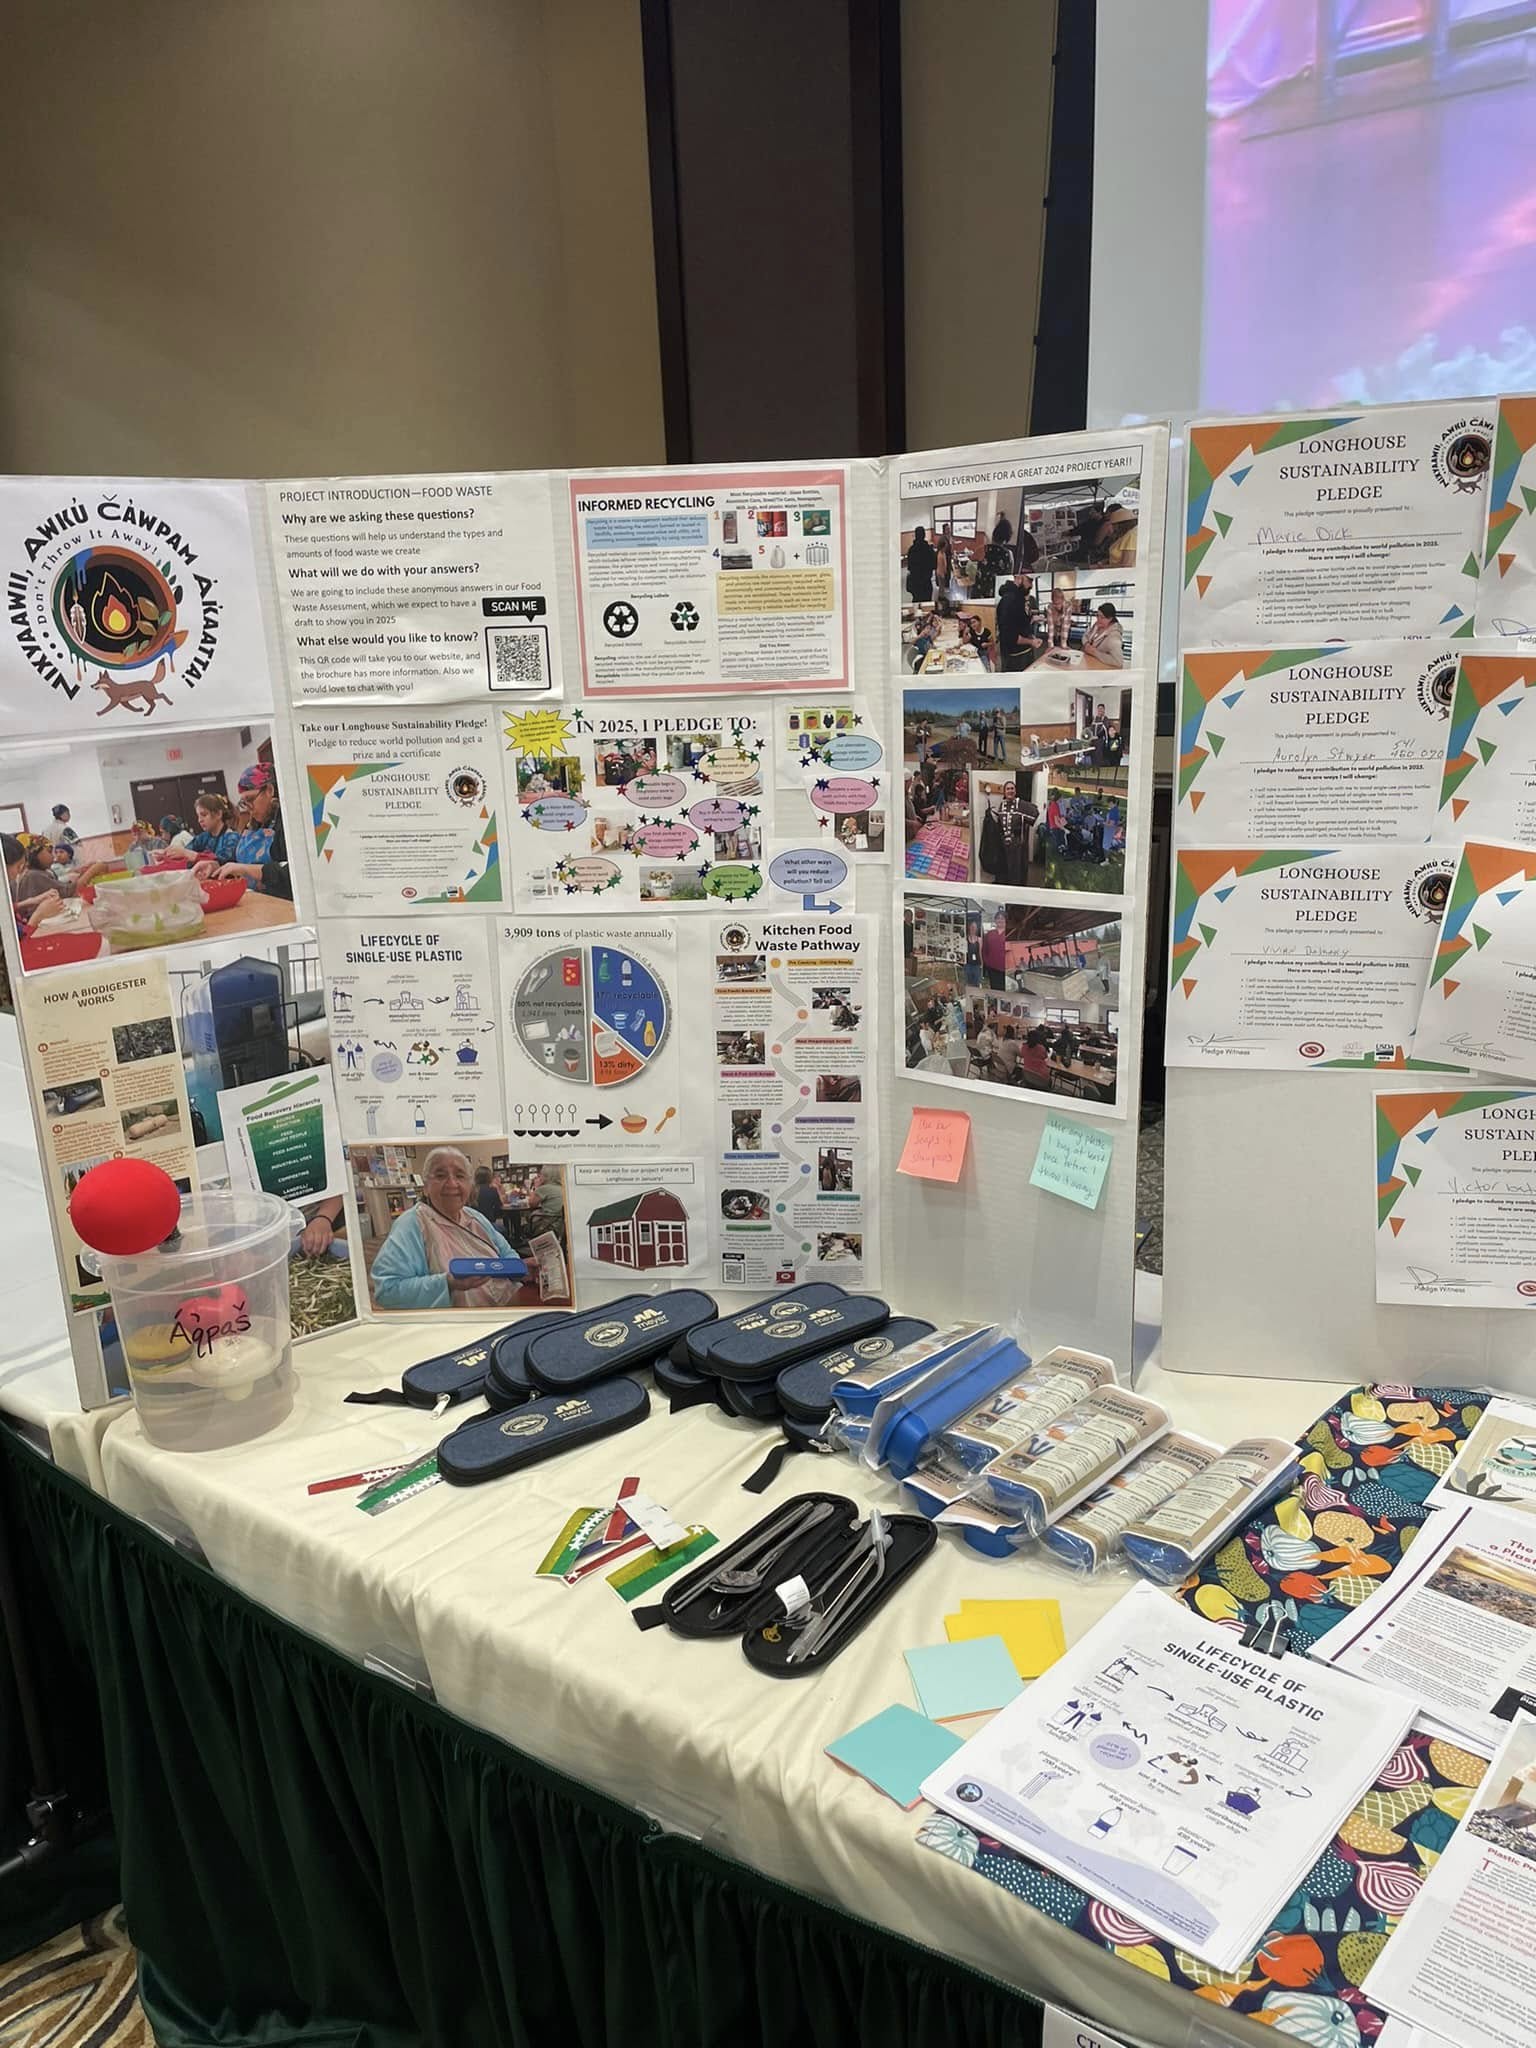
[0,428,1167,1403]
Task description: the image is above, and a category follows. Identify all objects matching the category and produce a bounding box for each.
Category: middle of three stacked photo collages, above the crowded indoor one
[901,682,1133,895]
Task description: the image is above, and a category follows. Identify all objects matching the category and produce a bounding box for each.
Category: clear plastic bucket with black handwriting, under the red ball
[96,1192,293,1450]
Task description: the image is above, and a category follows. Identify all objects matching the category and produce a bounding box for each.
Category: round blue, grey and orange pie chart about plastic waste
[512,944,672,1087]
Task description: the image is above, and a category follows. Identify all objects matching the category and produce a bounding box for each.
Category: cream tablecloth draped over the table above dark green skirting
[102,1319,1331,2048]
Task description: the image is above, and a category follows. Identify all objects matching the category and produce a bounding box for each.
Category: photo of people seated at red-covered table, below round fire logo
[0,725,293,973]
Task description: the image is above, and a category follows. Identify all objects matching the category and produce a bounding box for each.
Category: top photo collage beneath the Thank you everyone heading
[897,477,1141,676]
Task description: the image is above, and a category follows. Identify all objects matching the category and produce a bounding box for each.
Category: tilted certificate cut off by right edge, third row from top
[1415,840,1536,1081]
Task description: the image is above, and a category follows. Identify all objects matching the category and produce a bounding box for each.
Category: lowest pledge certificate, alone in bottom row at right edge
[1374,1087,1536,1309]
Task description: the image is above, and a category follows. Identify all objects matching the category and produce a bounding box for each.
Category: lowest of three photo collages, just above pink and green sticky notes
[901,891,1120,1106]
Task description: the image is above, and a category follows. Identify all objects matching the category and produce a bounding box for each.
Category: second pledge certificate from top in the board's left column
[1178,641,1458,846]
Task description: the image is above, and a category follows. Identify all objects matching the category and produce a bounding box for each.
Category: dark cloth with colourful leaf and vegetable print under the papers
[918,1386,1487,2048]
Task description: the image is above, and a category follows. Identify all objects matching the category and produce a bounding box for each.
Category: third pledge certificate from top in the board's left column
[1167,844,1456,1071]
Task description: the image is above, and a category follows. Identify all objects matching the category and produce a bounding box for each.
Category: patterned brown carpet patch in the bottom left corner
[0,1907,154,2048]
